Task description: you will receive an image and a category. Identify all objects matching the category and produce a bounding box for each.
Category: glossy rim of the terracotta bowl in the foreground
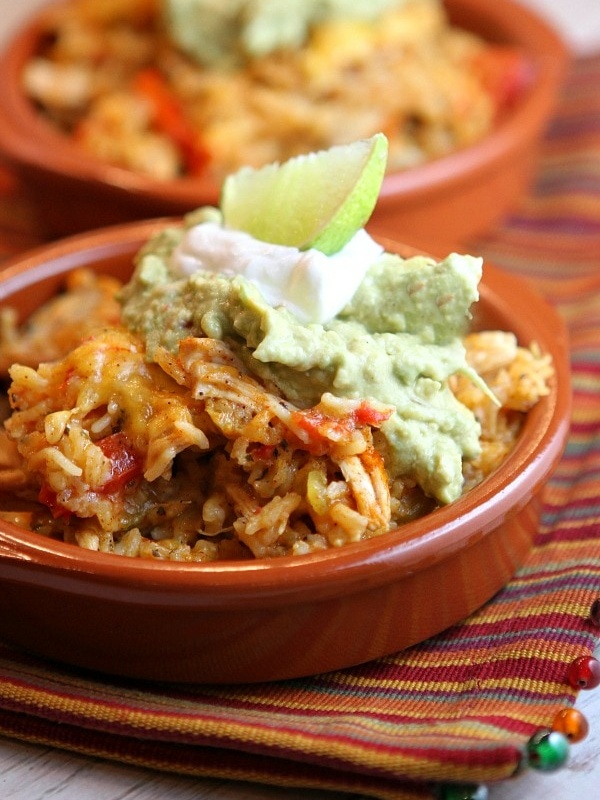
[0,218,571,608]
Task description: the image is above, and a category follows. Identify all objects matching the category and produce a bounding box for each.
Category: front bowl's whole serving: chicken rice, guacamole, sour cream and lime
[3,135,553,561]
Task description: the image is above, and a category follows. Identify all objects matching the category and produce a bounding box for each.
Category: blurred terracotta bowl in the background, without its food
[0,0,567,247]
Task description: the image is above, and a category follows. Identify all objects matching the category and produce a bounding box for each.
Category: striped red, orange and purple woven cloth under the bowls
[0,57,600,800]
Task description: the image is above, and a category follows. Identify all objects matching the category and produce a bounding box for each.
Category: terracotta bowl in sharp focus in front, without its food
[0,220,571,683]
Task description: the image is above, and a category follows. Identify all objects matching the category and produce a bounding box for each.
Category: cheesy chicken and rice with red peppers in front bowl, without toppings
[0,252,553,562]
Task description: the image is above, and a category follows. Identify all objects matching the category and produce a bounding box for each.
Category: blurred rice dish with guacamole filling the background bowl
[23,0,534,181]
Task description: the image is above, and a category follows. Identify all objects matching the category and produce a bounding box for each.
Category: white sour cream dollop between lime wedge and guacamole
[169,222,383,324]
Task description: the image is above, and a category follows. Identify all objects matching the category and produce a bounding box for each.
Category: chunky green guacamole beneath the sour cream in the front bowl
[122,209,482,503]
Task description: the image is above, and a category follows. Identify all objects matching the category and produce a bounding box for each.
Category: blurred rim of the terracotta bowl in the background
[0,0,569,207]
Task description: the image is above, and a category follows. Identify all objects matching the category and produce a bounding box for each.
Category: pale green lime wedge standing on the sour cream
[221,133,388,255]
